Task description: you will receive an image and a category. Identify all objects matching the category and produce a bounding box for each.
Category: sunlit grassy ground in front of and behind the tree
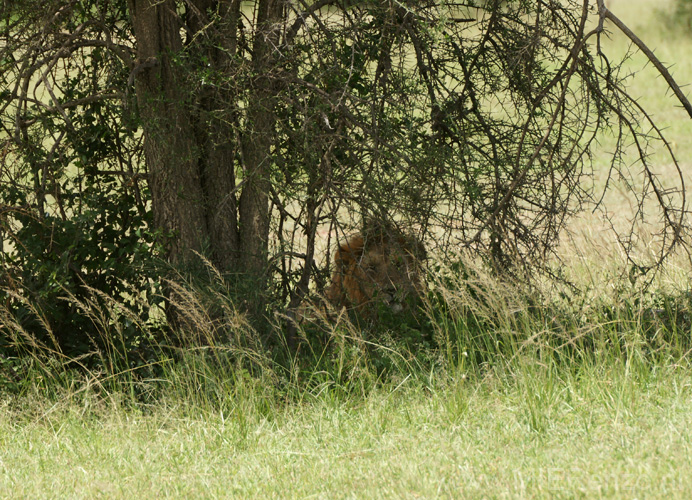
[0,0,692,499]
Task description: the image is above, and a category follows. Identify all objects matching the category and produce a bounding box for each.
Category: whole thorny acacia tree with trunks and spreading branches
[0,0,690,352]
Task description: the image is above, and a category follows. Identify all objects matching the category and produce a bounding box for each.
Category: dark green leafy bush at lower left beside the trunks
[0,182,160,357]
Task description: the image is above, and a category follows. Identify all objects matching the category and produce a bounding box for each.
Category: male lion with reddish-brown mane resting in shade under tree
[326,228,425,317]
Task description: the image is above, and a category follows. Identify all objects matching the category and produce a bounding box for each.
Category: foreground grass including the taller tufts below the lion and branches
[0,272,692,498]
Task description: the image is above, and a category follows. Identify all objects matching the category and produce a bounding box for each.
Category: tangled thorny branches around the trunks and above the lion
[0,0,692,307]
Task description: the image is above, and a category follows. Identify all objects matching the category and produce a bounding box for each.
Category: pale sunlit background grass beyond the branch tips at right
[561,0,692,289]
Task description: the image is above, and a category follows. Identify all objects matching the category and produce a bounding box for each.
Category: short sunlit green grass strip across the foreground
[0,359,692,498]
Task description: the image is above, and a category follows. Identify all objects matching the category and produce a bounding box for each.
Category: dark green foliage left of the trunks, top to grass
[0,1,161,373]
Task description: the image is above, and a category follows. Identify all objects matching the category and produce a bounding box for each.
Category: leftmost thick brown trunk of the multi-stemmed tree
[129,0,208,265]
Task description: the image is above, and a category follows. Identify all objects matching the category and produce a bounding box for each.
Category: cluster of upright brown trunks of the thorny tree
[129,0,284,328]
